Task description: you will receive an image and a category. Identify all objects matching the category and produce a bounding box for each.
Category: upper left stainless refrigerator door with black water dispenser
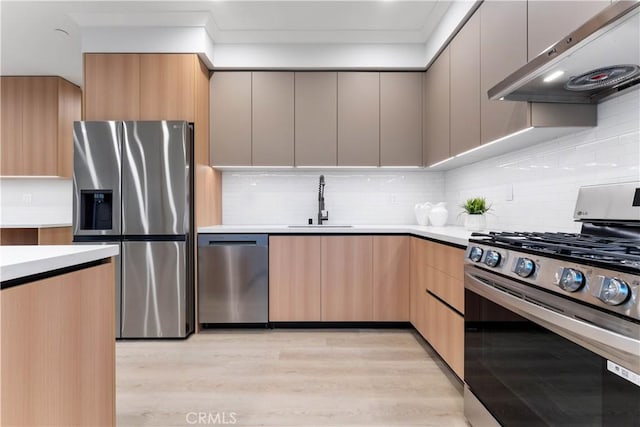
[73,121,122,236]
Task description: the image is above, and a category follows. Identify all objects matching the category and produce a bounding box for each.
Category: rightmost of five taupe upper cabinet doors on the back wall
[380,72,422,166]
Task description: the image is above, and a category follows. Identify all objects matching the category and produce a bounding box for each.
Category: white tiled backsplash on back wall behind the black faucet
[222,169,444,225]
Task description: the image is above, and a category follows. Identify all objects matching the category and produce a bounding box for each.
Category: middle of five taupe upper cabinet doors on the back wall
[295,72,338,166]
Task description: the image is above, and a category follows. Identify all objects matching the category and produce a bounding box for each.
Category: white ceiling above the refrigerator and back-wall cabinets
[0,0,462,85]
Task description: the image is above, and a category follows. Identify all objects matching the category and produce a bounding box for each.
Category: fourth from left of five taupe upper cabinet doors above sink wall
[338,72,380,166]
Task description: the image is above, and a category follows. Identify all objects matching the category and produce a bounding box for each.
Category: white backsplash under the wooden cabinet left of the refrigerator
[0,178,73,226]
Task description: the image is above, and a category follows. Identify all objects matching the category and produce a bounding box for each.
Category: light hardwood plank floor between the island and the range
[116,329,467,427]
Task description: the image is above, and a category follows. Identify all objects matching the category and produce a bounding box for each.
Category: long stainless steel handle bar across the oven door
[464,270,640,372]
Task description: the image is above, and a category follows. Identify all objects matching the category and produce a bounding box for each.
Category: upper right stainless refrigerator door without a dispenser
[122,121,190,235]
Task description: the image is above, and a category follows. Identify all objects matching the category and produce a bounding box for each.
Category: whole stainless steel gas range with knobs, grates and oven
[464,182,640,427]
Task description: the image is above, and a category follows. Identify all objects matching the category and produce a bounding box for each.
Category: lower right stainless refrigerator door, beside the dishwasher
[122,241,193,338]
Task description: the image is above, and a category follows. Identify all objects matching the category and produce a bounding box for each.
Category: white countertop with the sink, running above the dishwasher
[198,225,471,246]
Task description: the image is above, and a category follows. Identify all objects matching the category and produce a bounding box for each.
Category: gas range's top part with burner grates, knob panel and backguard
[465,182,640,323]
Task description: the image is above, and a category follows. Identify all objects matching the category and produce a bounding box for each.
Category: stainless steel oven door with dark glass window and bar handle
[465,265,640,427]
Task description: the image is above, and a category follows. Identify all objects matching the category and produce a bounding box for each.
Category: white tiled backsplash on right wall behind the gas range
[445,91,640,232]
